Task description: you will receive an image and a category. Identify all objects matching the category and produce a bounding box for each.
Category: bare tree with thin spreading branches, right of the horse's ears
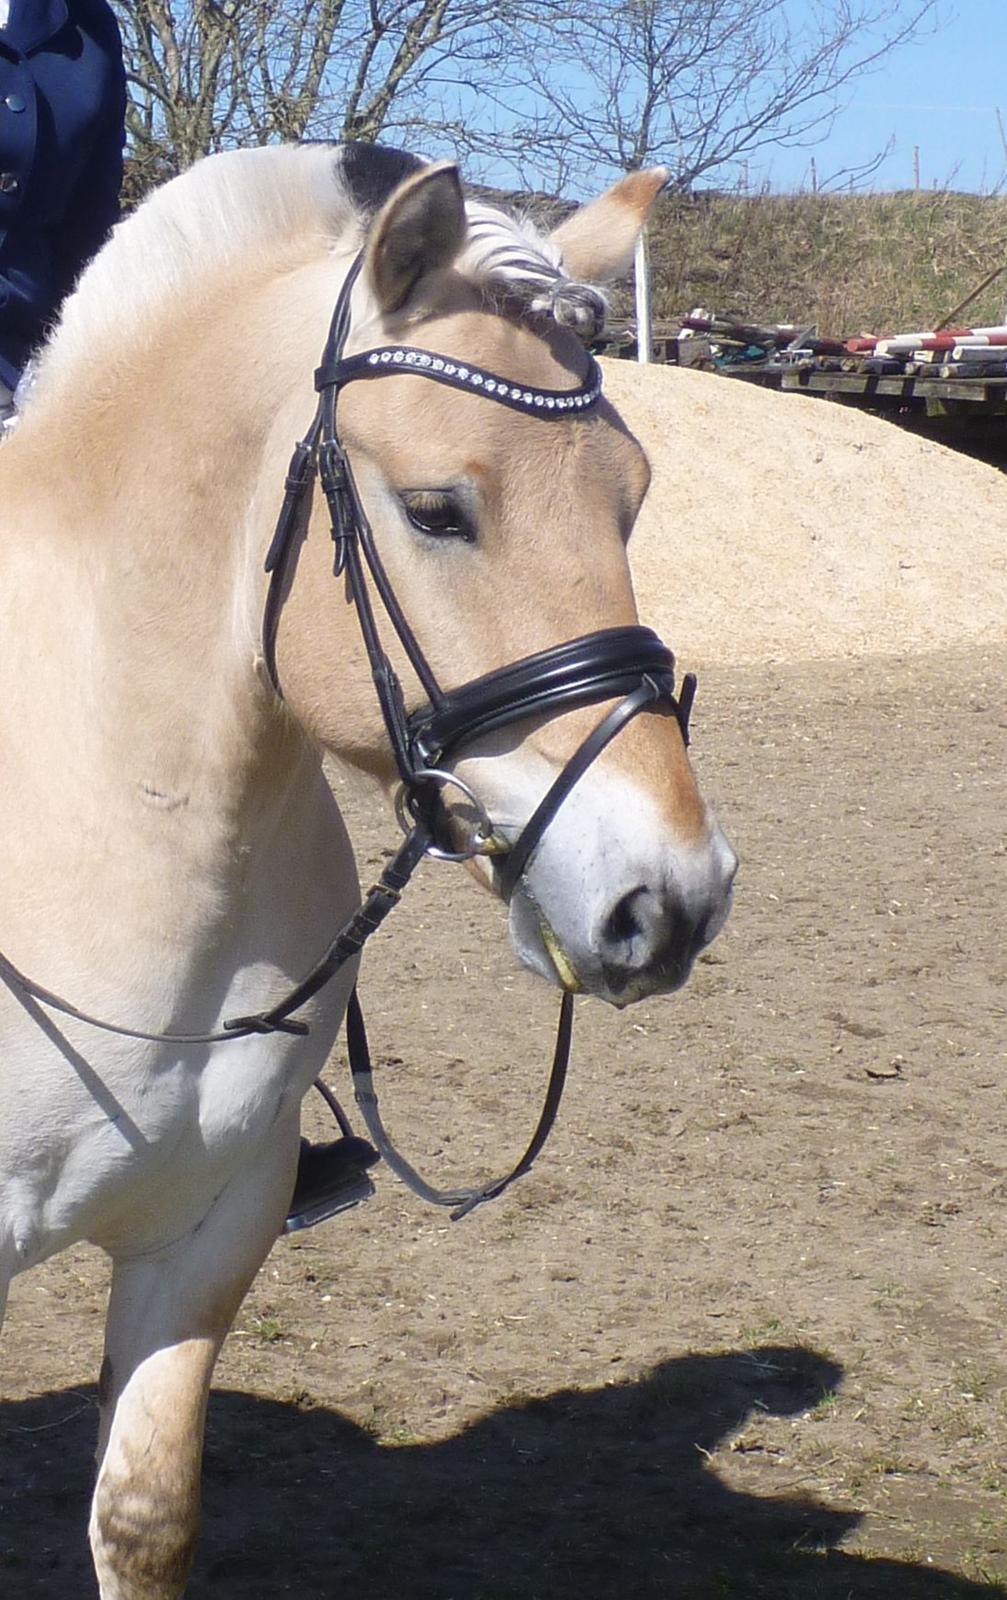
[499,0,938,189]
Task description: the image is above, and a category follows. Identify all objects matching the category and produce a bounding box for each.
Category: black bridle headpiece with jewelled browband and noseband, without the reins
[263,254,696,899]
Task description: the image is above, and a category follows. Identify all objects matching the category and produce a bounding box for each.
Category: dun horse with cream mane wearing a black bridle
[0,144,736,1600]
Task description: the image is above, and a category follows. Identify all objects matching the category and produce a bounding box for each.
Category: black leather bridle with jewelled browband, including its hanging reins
[0,254,696,1218]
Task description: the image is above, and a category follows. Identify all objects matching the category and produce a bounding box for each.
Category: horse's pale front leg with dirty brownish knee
[90,1122,298,1600]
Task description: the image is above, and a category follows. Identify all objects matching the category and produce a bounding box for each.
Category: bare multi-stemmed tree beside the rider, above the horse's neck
[114,0,512,192]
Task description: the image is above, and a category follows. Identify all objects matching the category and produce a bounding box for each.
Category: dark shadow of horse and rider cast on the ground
[0,1346,1007,1600]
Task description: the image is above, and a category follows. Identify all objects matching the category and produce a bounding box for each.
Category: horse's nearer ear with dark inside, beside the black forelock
[367,162,466,312]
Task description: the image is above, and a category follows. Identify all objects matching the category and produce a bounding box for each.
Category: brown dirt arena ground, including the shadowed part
[0,650,1007,1600]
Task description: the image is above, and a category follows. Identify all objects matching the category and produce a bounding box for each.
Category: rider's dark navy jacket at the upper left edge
[0,0,126,389]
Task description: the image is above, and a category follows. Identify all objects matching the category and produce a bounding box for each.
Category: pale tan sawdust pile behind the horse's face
[604,362,1007,664]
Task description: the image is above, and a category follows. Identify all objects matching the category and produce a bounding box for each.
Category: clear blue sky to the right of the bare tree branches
[762,0,1007,192]
